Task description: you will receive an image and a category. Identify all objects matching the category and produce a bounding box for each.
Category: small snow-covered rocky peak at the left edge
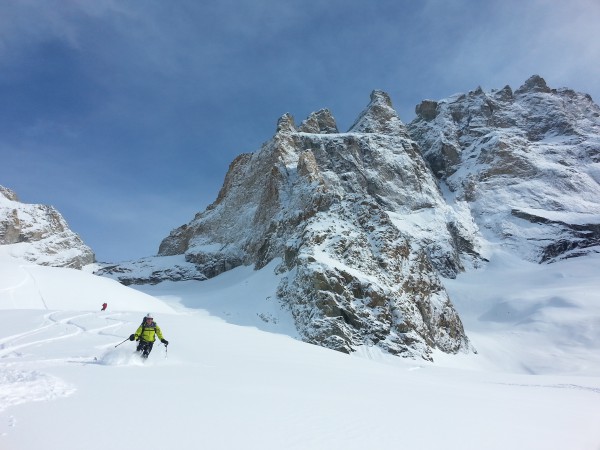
[0,186,95,269]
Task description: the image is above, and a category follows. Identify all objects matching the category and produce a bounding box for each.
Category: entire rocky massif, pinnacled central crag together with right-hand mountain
[102,76,600,359]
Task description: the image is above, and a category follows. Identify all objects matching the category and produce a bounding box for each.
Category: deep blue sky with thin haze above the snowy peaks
[0,0,600,262]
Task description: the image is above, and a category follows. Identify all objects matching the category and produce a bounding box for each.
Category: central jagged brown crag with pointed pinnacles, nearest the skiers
[150,91,474,358]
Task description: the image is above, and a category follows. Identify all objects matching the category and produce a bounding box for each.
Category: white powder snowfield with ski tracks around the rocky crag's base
[0,247,600,450]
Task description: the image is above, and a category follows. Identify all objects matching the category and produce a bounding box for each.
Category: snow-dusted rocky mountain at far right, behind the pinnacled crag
[408,75,600,262]
